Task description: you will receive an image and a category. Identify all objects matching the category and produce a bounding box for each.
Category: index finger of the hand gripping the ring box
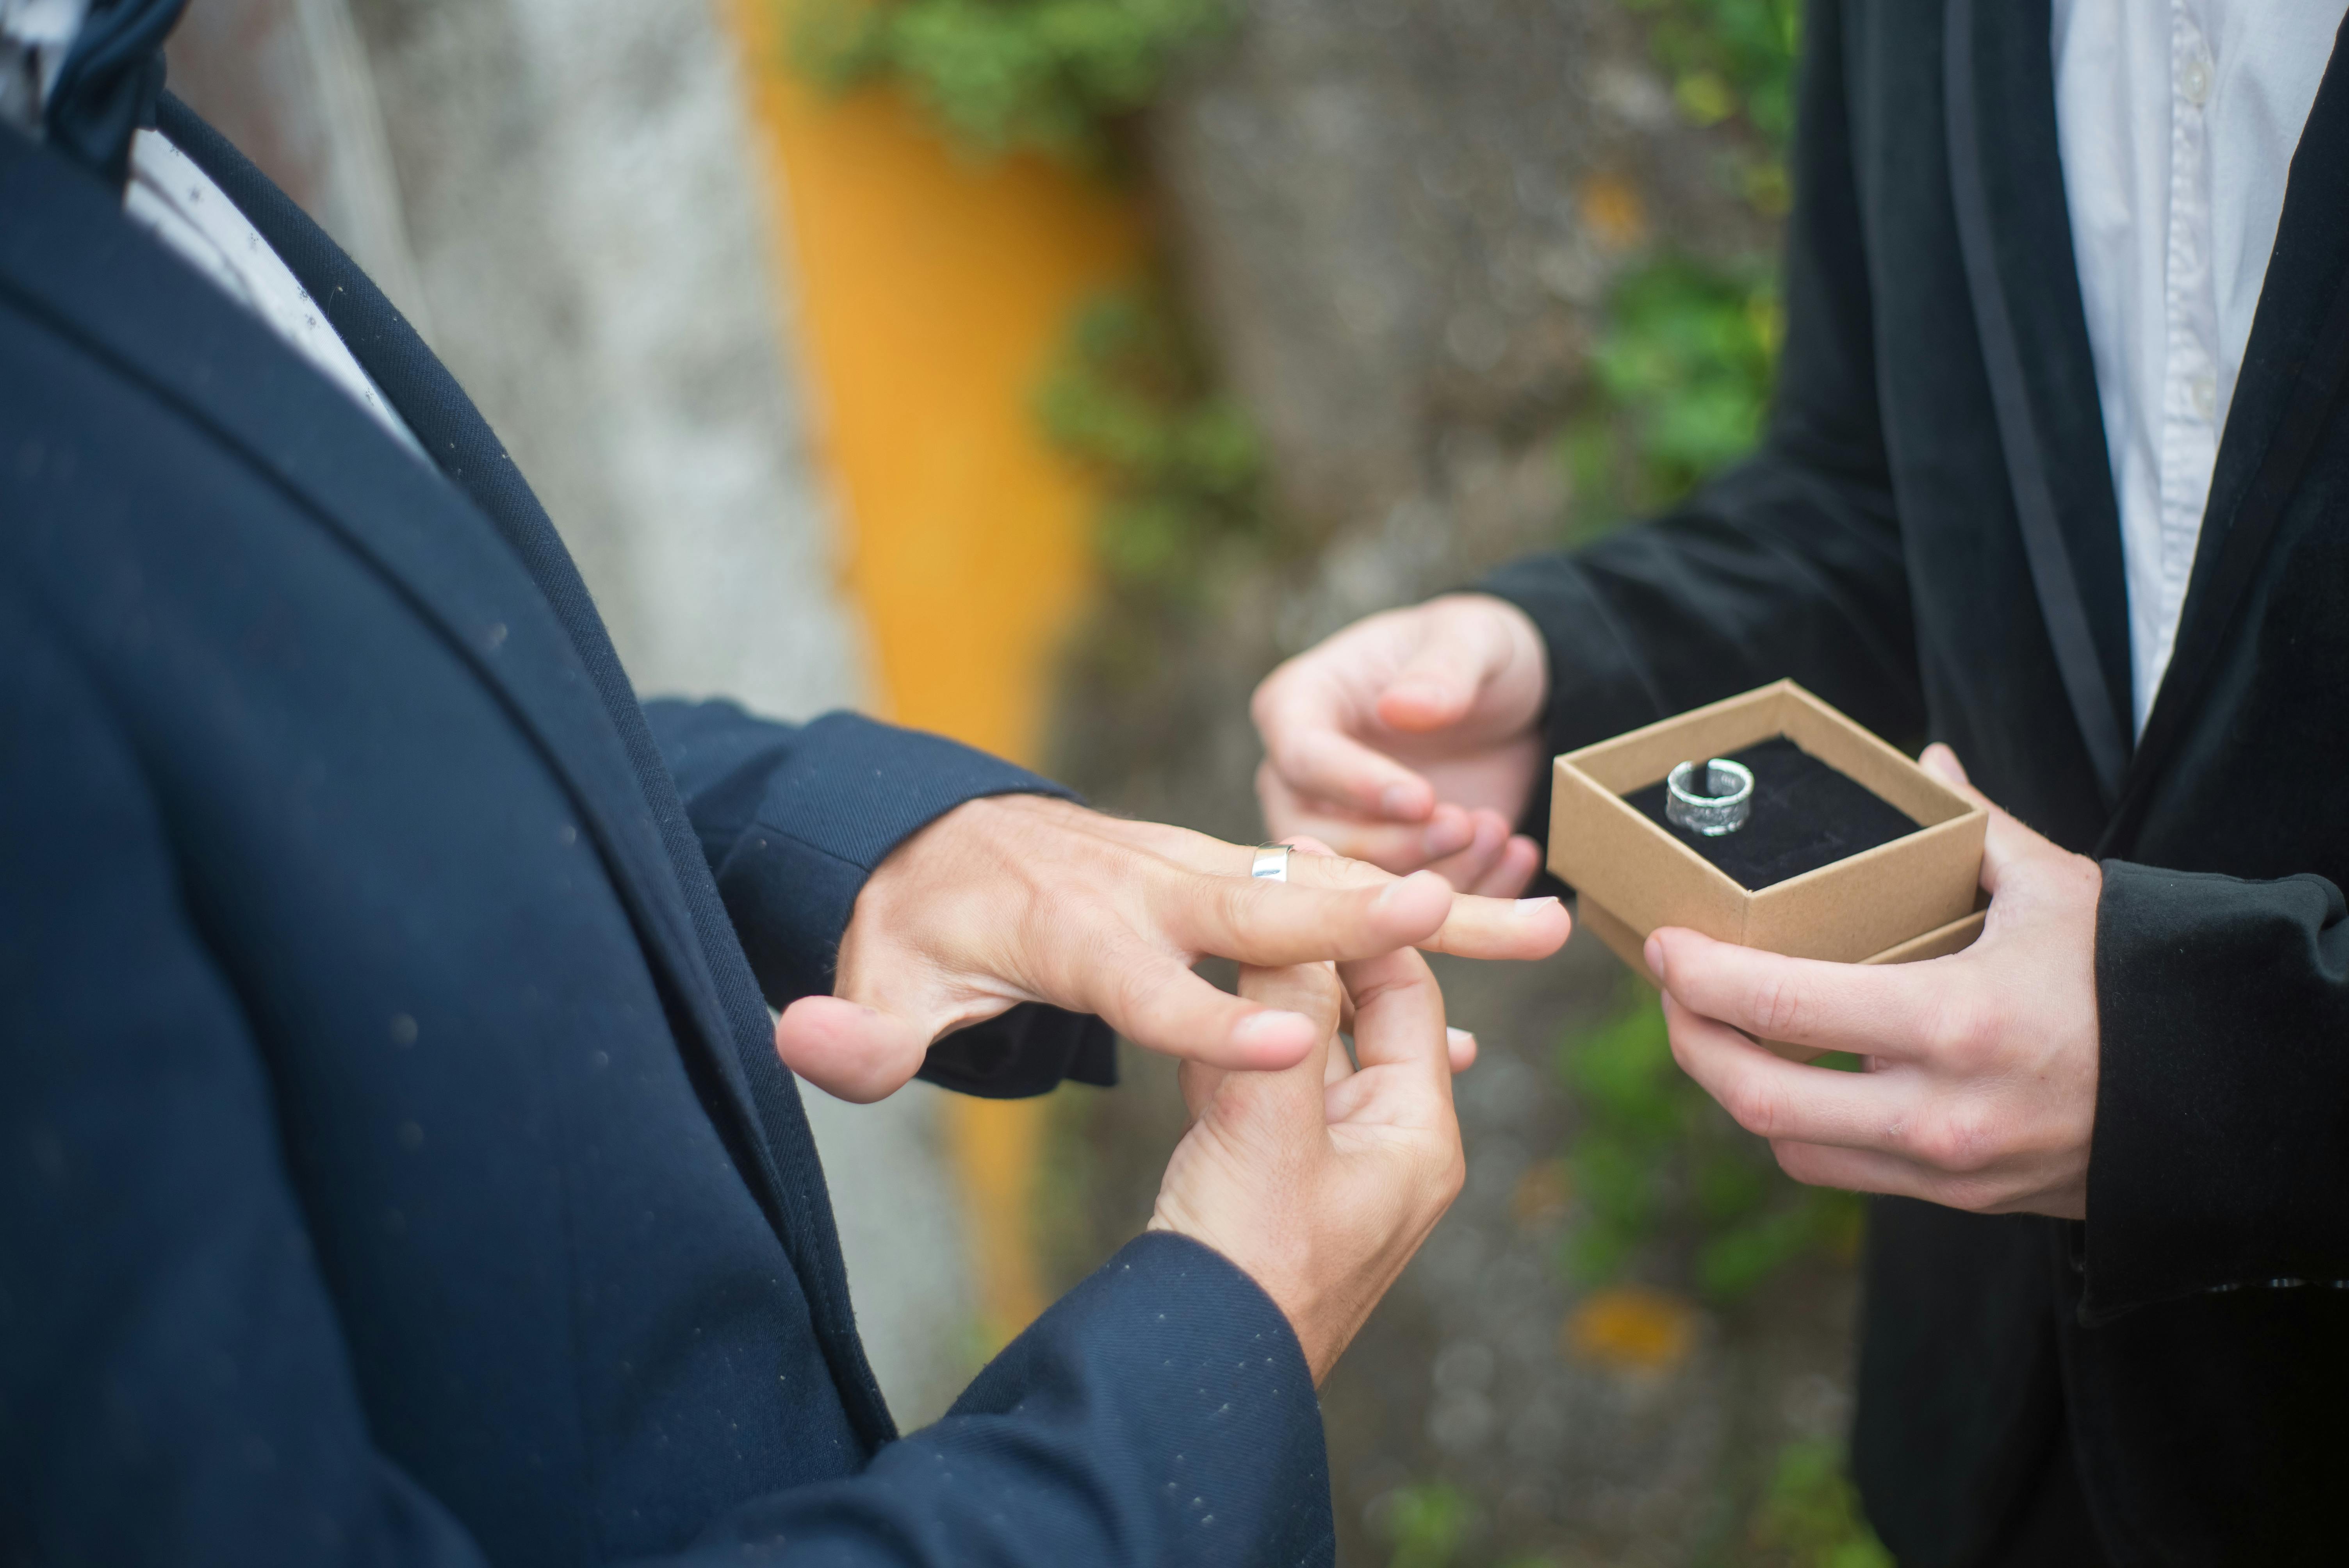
[1647,927,1945,1058]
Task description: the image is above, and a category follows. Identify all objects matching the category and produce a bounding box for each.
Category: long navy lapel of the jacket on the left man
[0,116,893,1443]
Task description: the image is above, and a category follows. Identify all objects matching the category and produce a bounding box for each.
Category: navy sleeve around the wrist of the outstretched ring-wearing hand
[643,702,1118,1099]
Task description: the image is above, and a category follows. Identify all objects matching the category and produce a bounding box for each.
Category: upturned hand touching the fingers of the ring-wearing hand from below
[1151,948,1468,1387]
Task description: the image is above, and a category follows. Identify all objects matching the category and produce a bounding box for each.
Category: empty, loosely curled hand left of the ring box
[1252,594,1551,899]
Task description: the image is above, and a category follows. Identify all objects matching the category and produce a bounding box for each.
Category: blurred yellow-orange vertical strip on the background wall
[721,0,1144,1350]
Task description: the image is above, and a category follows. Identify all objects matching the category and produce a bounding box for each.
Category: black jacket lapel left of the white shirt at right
[1943,0,2131,807]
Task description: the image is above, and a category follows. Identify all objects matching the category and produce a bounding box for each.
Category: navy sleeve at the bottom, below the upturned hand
[686,1232,1337,1568]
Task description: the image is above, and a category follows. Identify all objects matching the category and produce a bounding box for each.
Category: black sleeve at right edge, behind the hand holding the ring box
[2079,861,2349,1322]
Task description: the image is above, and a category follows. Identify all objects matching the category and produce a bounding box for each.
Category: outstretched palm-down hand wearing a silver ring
[775,796,1569,1101]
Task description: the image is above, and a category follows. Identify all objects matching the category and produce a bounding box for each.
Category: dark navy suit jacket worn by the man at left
[0,101,1330,1566]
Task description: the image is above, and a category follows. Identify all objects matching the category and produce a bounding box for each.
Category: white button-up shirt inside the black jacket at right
[2053,0,2349,735]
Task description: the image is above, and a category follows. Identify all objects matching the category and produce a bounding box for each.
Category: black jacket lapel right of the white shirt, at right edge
[2107,21,2349,838]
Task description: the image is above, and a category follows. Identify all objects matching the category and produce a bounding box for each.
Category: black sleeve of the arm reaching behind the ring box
[1477,5,1924,836]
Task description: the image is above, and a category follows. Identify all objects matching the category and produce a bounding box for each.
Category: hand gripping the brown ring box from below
[1647,747,2102,1218]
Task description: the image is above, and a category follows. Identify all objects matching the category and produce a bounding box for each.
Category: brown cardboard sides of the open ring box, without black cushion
[1551,681,1990,979]
